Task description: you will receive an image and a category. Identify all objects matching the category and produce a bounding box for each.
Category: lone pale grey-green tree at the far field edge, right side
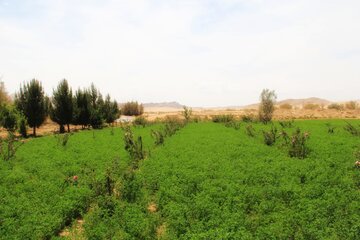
[259,89,277,124]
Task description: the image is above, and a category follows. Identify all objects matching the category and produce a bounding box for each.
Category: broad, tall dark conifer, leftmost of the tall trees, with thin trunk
[15,79,47,136]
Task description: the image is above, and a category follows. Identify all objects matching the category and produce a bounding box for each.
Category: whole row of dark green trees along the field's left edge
[0,79,120,136]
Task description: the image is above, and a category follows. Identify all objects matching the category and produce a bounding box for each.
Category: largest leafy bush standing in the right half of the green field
[289,128,310,159]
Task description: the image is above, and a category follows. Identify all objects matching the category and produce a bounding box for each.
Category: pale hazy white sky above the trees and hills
[0,0,360,106]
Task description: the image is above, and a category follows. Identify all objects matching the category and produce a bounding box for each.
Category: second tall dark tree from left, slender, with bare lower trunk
[50,79,73,132]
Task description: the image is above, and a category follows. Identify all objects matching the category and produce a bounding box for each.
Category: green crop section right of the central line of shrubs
[103,121,360,239]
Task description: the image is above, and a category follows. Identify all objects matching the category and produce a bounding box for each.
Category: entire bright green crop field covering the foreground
[0,120,360,239]
